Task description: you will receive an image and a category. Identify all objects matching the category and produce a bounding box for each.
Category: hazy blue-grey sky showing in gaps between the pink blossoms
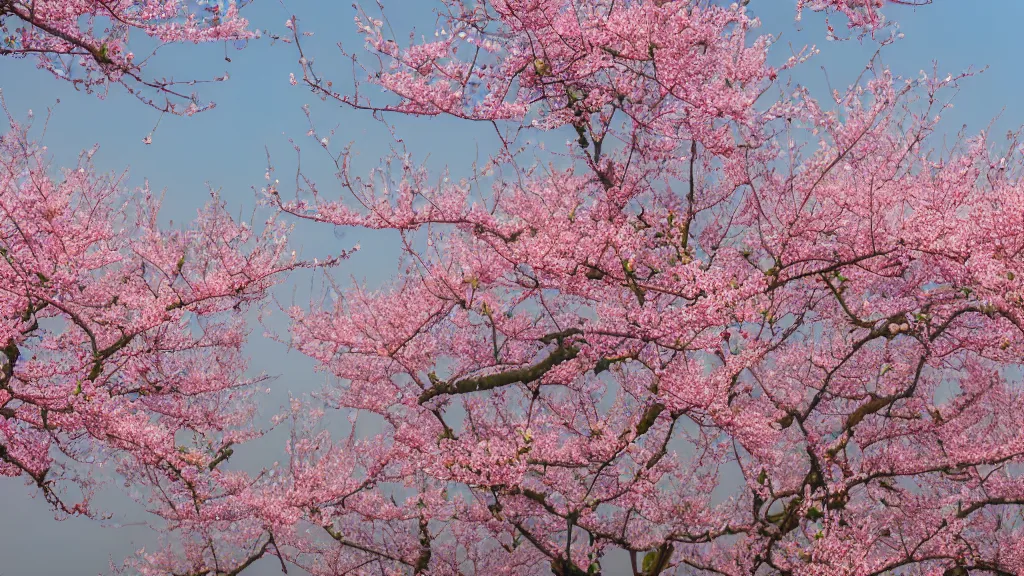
[0,0,1024,576]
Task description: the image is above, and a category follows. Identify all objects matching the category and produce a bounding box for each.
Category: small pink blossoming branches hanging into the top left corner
[0,0,251,115]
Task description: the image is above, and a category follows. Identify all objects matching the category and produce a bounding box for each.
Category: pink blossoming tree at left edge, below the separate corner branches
[0,107,311,564]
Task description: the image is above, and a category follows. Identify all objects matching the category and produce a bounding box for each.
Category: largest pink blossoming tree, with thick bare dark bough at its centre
[269,0,1024,576]
